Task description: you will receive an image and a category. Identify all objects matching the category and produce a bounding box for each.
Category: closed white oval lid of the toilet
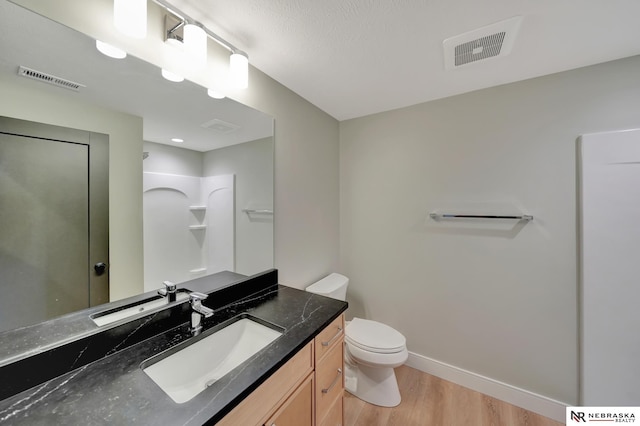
[345,318,407,353]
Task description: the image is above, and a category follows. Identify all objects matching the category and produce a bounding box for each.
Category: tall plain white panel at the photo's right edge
[580,130,640,406]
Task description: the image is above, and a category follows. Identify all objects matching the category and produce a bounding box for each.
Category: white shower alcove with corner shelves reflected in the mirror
[143,137,273,291]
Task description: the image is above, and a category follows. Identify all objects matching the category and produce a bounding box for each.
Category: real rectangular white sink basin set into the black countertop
[142,318,282,404]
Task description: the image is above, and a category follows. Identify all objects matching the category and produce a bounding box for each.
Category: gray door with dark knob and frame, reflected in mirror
[0,118,108,331]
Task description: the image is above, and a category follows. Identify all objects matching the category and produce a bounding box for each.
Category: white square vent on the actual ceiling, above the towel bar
[442,16,522,69]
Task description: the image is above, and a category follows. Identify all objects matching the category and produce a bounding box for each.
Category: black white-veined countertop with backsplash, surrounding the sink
[0,271,347,425]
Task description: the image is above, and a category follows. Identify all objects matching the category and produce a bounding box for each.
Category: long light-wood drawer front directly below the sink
[218,342,313,426]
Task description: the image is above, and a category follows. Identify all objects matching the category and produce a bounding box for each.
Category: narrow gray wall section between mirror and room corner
[235,72,340,288]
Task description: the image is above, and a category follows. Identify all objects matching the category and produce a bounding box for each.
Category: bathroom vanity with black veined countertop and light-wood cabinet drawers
[0,270,347,426]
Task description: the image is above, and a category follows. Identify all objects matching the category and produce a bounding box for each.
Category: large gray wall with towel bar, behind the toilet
[340,53,640,403]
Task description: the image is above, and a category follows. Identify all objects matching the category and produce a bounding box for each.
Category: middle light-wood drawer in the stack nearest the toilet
[316,338,344,420]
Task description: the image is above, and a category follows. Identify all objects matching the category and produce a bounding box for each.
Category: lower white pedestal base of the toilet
[345,363,401,407]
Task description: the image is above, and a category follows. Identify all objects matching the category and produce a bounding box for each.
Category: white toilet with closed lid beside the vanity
[306,273,409,407]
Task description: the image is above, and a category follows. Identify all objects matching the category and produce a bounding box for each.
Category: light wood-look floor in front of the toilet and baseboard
[344,366,562,426]
